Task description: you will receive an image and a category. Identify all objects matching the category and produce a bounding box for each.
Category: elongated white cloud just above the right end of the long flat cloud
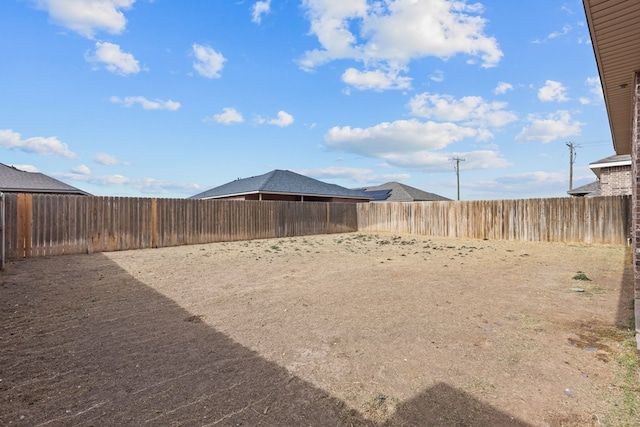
[409,92,517,127]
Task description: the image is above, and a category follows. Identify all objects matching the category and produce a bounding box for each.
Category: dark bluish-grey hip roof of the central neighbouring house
[190,169,369,200]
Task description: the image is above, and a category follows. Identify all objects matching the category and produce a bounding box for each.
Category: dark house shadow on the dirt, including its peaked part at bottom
[0,254,526,426]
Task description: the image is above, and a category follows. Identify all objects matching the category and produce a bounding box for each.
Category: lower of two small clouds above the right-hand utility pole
[516,110,584,143]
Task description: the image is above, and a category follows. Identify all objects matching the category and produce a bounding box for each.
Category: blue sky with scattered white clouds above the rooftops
[0,0,614,200]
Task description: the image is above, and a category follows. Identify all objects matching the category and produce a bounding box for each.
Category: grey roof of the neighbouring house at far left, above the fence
[0,163,91,196]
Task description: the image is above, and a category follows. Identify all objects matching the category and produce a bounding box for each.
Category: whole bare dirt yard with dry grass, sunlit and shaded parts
[0,233,639,426]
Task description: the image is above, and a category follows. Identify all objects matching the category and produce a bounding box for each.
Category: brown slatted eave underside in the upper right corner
[583,0,640,154]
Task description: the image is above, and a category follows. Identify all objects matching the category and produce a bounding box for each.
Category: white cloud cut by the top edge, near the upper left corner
[33,0,136,38]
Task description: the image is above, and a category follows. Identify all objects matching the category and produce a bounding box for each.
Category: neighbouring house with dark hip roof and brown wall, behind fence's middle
[189,169,369,203]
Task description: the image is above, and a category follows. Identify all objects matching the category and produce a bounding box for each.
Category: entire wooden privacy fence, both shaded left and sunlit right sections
[3,194,631,259]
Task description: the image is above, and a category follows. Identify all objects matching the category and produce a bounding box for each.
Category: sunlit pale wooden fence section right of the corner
[358,196,631,244]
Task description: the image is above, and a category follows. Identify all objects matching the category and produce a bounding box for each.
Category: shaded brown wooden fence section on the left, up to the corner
[5,194,358,259]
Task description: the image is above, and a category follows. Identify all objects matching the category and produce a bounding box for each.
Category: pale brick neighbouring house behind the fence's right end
[567,154,631,197]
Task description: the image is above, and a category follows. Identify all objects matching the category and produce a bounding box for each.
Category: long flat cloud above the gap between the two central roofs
[324,119,481,157]
